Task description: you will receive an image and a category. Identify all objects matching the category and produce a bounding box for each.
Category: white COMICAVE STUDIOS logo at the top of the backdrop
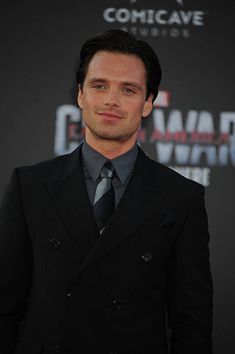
[102,0,208,38]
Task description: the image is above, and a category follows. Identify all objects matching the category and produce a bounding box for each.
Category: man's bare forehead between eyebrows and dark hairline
[86,51,146,84]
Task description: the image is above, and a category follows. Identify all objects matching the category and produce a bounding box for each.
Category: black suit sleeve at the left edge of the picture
[0,169,32,354]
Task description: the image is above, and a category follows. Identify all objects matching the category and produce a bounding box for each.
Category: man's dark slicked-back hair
[77,29,161,101]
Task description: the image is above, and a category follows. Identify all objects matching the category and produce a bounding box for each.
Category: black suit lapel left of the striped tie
[47,147,99,248]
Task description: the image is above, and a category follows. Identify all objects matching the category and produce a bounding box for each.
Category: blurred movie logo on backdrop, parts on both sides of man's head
[54,91,235,186]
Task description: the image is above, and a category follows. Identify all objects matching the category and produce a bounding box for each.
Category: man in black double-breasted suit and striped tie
[0,30,212,354]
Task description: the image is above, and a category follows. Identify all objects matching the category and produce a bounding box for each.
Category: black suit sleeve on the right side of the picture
[167,186,213,354]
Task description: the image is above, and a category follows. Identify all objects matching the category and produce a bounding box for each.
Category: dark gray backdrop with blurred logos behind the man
[0,0,235,354]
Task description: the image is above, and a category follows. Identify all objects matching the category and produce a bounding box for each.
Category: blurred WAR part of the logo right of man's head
[149,91,235,186]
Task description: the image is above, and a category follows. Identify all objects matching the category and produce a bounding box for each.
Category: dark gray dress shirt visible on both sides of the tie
[82,141,138,207]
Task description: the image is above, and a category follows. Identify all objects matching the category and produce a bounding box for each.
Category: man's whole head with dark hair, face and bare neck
[77,30,161,157]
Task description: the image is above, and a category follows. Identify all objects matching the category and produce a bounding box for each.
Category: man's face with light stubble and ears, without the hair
[78,51,152,147]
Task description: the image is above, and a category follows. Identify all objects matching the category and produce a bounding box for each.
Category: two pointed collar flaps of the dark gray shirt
[82,141,138,183]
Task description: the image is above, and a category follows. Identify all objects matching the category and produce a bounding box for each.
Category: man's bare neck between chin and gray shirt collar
[85,136,136,160]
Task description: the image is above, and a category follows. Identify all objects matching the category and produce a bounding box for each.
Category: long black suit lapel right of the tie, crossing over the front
[74,150,166,277]
